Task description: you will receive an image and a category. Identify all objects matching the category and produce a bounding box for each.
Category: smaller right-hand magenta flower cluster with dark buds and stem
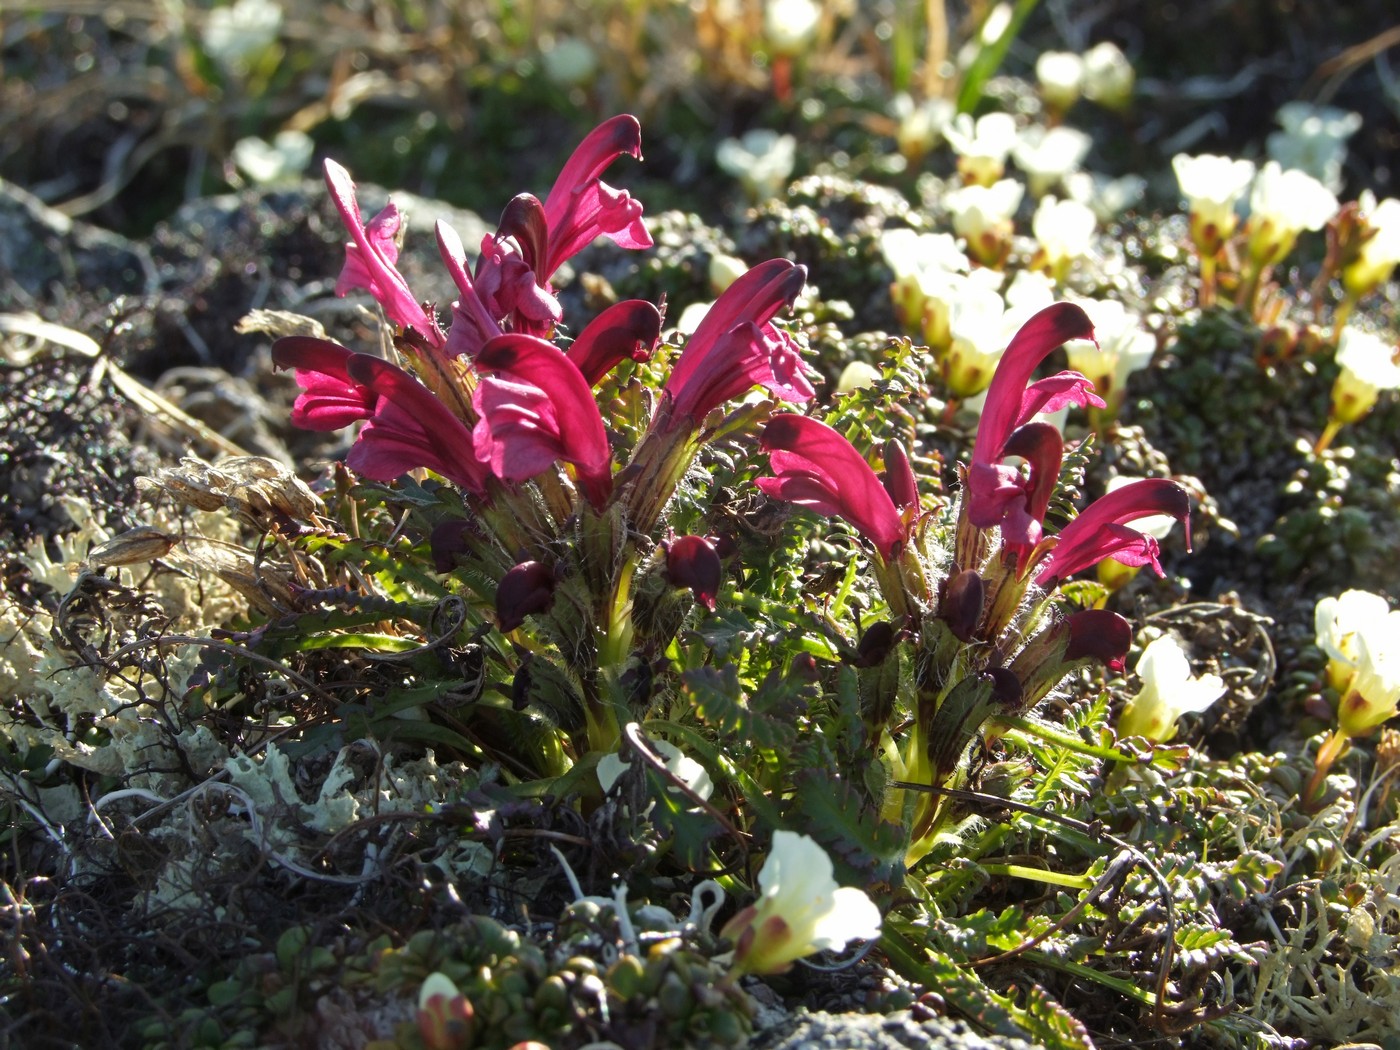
[757,302,1190,860]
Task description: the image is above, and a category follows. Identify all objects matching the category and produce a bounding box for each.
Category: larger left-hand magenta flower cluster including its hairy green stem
[273,116,813,750]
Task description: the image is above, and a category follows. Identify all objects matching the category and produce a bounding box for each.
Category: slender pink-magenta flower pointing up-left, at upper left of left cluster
[325,160,445,347]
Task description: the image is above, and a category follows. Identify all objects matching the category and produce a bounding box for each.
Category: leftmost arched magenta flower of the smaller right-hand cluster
[757,413,909,561]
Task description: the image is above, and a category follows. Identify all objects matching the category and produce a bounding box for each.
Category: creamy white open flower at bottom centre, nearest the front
[721,832,881,973]
